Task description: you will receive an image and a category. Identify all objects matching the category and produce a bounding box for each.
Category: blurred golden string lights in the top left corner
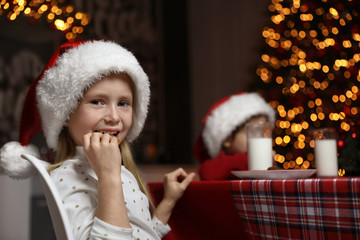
[0,0,90,41]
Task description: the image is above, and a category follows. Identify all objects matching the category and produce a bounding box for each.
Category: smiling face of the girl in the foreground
[67,73,133,146]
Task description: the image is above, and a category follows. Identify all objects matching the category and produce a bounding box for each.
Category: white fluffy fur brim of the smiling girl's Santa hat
[36,41,150,150]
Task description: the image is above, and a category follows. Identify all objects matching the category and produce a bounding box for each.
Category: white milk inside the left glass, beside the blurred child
[248,138,272,170]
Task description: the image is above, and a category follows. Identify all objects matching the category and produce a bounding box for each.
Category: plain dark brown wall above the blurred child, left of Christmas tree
[188,0,268,141]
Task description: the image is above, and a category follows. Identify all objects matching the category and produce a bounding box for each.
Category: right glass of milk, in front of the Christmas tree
[314,128,339,177]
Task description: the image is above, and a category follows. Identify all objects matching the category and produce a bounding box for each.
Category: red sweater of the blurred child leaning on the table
[198,151,248,180]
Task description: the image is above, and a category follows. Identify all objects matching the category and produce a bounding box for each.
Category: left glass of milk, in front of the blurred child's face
[246,122,273,170]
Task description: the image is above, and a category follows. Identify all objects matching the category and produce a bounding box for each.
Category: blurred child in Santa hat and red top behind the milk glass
[193,92,275,180]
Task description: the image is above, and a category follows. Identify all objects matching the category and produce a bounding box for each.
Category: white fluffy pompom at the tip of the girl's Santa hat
[0,141,40,179]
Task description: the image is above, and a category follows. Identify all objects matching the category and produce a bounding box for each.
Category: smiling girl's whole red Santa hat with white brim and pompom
[0,41,150,178]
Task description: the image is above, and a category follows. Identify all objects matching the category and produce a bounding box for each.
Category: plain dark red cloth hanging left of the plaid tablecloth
[148,181,246,240]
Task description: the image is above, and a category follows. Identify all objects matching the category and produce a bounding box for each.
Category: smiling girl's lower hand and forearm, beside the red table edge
[155,168,195,224]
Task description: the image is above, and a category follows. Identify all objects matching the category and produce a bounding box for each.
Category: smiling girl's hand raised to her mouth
[83,132,122,178]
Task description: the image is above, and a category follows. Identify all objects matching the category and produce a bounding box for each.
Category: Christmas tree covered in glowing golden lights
[256,0,360,175]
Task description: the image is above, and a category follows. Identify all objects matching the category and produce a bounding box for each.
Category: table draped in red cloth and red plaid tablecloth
[148,177,360,240]
